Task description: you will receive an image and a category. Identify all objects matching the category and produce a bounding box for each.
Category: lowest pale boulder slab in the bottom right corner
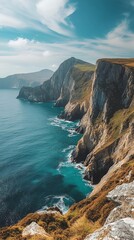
[85,218,134,240]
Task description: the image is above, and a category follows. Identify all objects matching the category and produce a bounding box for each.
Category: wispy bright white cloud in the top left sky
[0,0,76,36]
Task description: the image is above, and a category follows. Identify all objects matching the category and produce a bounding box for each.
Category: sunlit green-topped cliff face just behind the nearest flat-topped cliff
[60,70,94,121]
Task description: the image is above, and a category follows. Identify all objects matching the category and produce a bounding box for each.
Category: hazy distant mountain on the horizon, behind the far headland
[0,69,53,89]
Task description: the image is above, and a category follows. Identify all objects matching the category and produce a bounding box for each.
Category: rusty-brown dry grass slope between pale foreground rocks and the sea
[67,159,134,225]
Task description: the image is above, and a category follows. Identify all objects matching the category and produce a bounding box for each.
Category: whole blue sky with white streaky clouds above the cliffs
[0,0,134,77]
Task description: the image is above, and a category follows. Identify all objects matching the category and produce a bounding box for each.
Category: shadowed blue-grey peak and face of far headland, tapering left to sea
[18,57,94,106]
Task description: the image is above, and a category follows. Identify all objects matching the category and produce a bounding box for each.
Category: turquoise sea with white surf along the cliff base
[0,90,91,226]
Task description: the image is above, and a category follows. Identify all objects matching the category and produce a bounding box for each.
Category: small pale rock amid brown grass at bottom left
[22,222,49,238]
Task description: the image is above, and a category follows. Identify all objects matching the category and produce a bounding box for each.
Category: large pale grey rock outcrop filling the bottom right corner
[85,181,134,240]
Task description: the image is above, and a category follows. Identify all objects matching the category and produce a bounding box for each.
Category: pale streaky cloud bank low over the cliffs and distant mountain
[0,20,134,76]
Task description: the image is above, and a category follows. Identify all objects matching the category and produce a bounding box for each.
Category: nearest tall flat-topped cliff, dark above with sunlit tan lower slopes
[73,60,134,184]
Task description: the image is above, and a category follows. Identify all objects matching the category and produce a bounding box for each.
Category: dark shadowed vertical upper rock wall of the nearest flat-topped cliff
[91,60,134,122]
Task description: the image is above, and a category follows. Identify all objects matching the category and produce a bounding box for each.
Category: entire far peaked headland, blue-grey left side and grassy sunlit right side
[17,57,95,120]
